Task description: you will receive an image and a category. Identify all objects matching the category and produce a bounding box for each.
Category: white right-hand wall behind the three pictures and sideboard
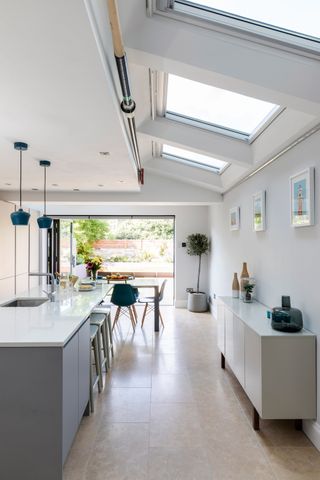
[209,133,320,448]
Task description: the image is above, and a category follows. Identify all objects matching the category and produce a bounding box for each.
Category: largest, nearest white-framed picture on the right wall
[290,167,314,227]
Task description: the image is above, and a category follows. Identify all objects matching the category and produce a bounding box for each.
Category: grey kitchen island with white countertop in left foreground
[0,287,110,480]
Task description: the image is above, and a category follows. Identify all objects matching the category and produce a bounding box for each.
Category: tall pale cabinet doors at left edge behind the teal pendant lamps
[0,201,39,298]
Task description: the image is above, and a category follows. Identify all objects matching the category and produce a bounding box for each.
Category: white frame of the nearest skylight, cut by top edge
[147,0,320,58]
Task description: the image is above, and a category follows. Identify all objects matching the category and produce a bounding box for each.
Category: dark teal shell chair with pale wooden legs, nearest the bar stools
[110,283,137,330]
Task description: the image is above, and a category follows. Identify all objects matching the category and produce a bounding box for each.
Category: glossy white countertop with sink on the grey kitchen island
[0,284,110,347]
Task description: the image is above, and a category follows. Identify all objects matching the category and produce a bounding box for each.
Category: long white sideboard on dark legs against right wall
[217,297,316,430]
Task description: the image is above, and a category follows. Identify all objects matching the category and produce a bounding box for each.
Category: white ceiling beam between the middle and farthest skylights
[138,117,253,167]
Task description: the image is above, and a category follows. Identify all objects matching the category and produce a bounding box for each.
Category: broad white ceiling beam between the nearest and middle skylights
[119,0,320,114]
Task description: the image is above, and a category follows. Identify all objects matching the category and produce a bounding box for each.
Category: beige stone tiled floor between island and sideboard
[64,307,320,480]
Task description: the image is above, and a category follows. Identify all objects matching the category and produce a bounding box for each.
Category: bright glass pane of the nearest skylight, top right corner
[176,0,320,37]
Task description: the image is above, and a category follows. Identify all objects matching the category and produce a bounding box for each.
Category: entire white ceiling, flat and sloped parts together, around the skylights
[0,0,320,214]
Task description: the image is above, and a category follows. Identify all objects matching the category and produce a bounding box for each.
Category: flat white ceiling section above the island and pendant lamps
[0,0,139,195]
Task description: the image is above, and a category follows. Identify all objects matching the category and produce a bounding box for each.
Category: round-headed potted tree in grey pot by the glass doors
[187,233,209,312]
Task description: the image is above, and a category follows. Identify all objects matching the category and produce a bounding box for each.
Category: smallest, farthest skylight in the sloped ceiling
[162,145,228,173]
